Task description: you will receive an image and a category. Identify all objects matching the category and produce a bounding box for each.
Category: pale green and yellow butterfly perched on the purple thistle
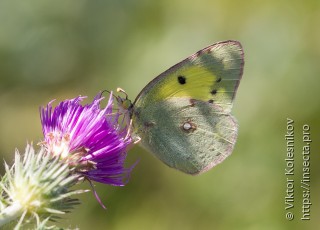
[119,40,244,175]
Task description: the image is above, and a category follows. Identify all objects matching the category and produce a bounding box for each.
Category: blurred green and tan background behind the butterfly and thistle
[0,0,320,230]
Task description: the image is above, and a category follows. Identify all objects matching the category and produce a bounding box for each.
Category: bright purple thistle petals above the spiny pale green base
[40,93,133,186]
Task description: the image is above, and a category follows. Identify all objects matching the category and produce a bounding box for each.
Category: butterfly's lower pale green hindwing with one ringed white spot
[134,98,237,174]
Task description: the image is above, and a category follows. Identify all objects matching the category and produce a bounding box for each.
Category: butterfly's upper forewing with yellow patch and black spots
[134,41,244,114]
